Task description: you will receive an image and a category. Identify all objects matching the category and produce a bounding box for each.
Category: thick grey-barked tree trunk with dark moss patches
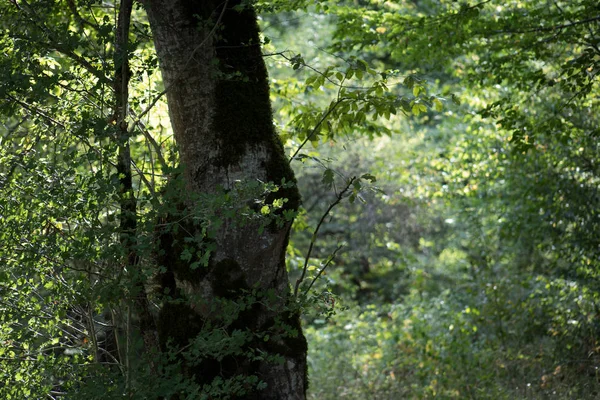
[144,0,307,400]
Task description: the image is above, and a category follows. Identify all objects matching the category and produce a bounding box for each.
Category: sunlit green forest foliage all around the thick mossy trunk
[0,0,600,399]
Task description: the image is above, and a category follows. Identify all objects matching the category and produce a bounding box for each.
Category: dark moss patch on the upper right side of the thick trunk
[213,1,300,210]
